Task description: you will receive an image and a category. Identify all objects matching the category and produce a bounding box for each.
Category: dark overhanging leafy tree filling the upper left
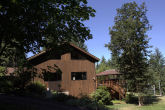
[0,0,95,56]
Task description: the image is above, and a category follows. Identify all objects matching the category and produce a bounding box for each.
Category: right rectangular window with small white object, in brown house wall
[71,72,87,80]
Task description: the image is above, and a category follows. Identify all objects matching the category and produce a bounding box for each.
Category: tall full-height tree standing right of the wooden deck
[106,2,151,106]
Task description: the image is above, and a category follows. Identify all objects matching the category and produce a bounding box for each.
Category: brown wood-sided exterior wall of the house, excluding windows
[32,53,96,96]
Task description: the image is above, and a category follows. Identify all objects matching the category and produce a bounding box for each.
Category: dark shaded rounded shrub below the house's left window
[25,82,46,96]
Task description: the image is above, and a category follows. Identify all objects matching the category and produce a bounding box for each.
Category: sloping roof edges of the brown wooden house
[28,43,100,62]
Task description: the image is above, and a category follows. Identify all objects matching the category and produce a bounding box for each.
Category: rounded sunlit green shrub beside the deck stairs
[91,87,111,105]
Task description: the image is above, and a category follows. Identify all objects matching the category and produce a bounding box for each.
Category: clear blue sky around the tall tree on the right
[85,0,165,60]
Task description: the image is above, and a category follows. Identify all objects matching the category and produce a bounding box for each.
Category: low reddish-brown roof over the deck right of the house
[96,69,121,76]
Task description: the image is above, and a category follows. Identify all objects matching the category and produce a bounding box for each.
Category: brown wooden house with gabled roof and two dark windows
[28,44,99,97]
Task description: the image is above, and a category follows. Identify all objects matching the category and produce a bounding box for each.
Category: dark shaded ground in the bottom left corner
[0,95,84,110]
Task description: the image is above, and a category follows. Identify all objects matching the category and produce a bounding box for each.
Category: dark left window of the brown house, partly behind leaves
[43,72,62,81]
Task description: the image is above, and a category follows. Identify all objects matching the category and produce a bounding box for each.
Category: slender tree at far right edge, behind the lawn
[149,48,165,95]
